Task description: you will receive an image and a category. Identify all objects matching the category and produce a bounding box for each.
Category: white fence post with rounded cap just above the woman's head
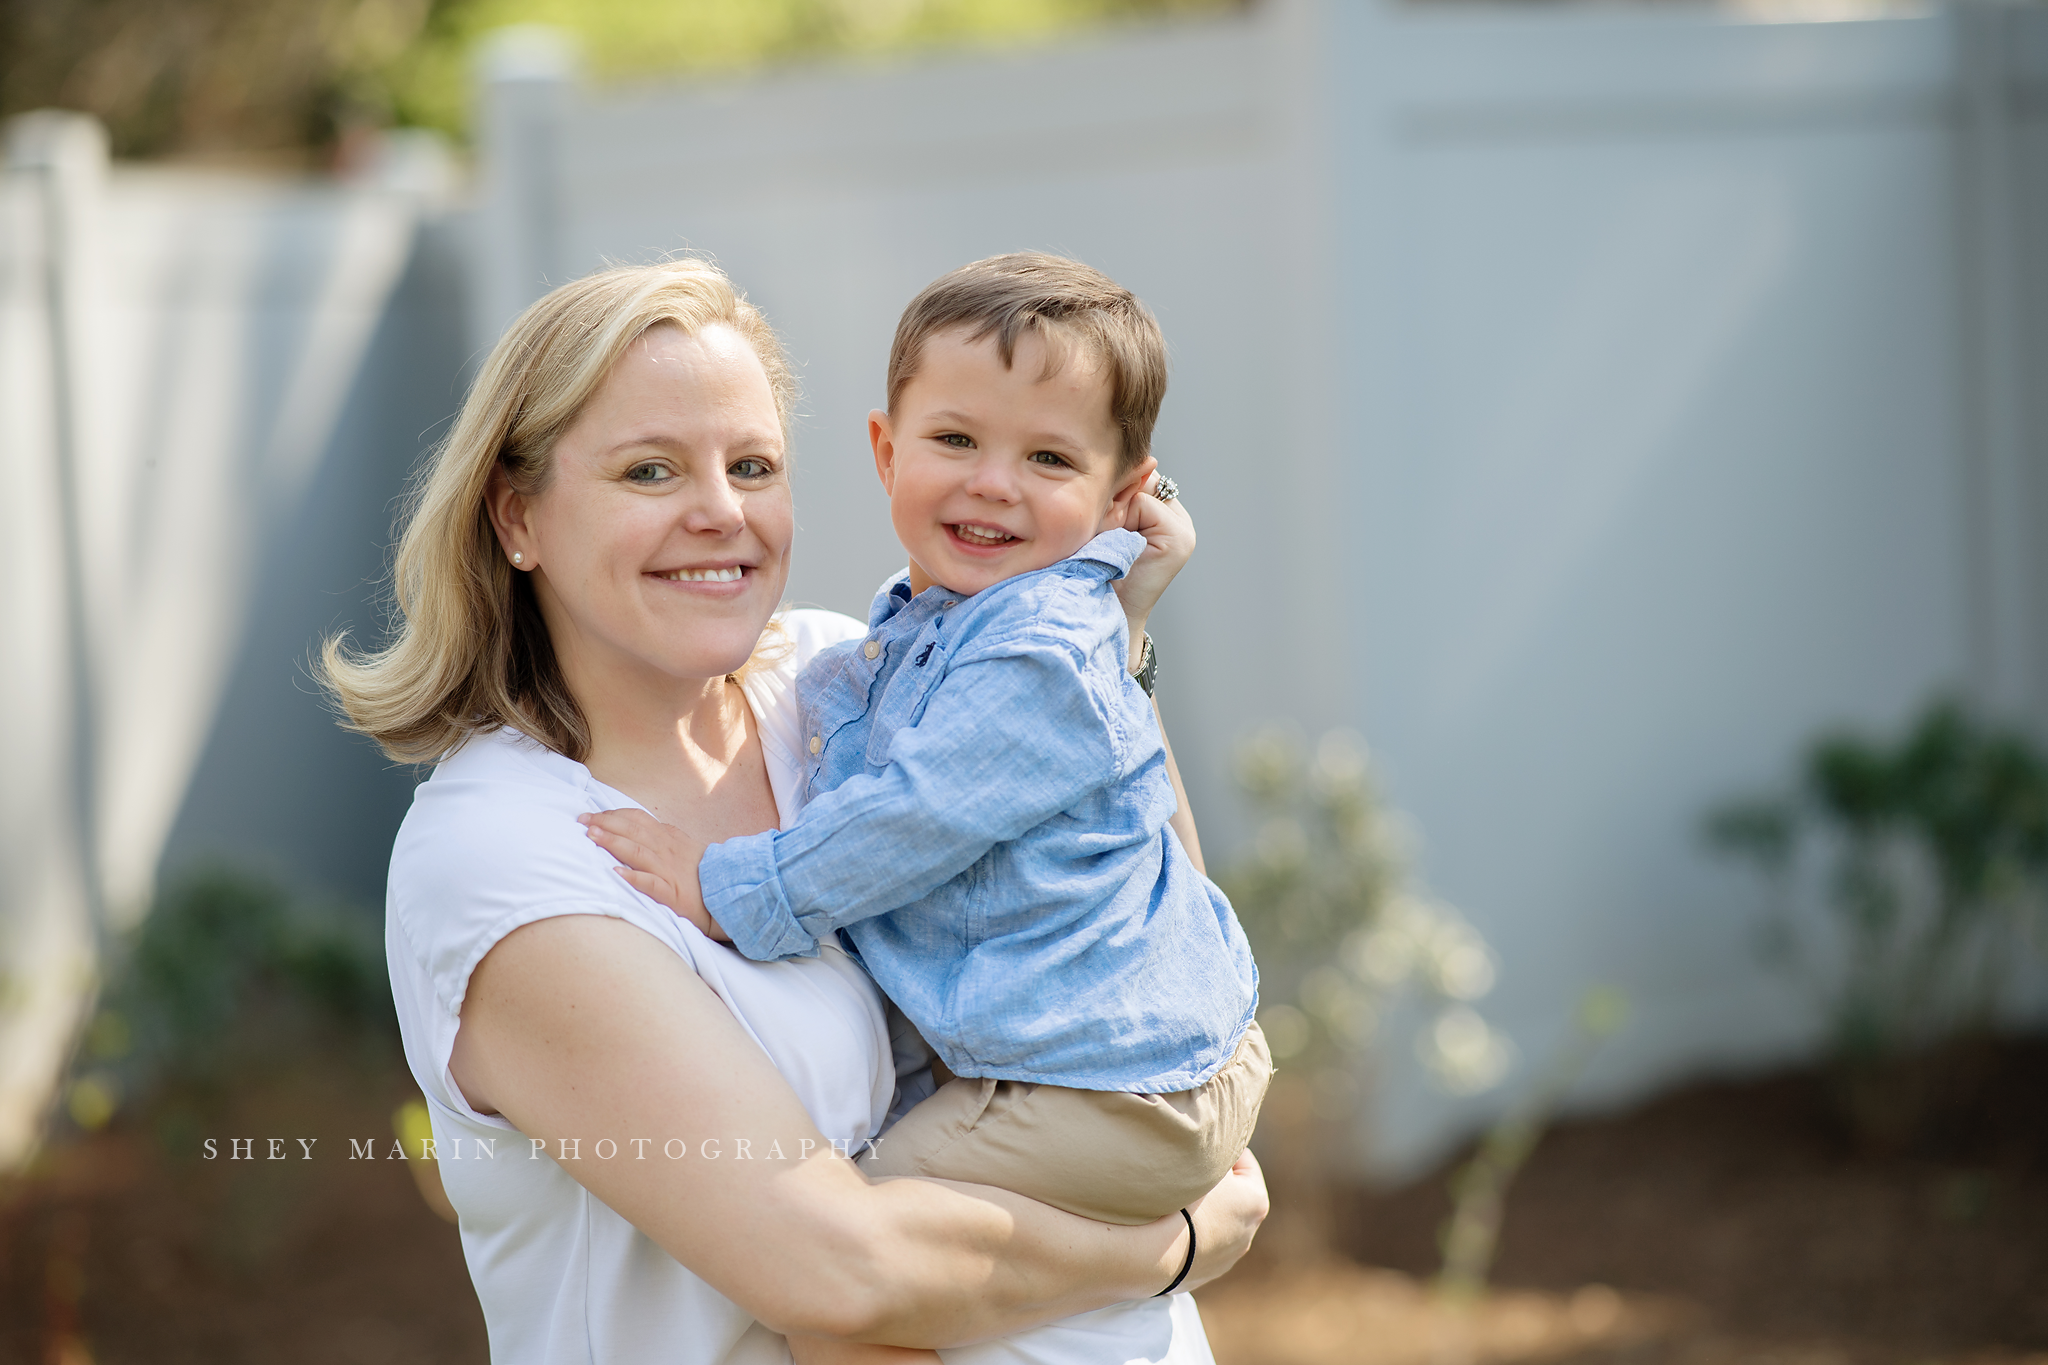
[471,25,575,350]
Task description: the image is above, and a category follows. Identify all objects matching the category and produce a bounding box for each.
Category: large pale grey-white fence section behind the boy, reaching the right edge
[473,0,2048,1169]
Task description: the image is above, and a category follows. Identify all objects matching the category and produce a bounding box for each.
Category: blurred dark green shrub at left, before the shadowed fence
[66,866,397,1130]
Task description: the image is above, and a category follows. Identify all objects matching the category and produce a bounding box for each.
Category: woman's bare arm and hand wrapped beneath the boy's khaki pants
[451,915,1266,1347]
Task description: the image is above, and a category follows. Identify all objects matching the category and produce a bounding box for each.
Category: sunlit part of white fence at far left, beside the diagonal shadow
[0,113,418,1171]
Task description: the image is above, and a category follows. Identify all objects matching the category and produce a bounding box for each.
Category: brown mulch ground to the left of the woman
[0,1064,489,1365]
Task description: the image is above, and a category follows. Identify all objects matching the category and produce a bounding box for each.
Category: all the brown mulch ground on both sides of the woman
[0,1040,2048,1365]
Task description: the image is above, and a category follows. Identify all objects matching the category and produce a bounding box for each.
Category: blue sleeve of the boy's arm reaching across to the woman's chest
[663,641,1120,960]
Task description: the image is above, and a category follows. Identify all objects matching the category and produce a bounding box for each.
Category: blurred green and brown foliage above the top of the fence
[0,0,1245,158]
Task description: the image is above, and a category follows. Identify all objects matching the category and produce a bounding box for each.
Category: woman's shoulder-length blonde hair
[317,258,797,763]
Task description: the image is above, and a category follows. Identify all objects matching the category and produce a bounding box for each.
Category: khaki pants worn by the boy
[860,1023,1274,1224]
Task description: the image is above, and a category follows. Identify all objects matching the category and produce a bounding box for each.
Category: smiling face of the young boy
[868,329,1155,596]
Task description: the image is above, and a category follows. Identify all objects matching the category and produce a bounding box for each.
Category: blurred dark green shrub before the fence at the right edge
[1704,702,2048,1136]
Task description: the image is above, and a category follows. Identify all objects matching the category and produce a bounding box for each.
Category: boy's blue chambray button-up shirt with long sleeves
[698,530,1257,1095]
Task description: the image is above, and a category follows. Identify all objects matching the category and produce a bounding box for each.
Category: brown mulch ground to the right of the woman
[1204,1040,2048,1365]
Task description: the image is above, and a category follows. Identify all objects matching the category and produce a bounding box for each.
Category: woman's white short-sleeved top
[385,610,1212,1365]
